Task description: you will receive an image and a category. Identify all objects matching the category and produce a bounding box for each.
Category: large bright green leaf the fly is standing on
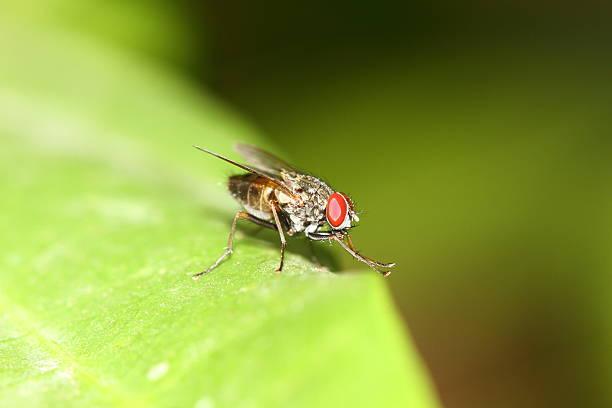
[0,13,436,408]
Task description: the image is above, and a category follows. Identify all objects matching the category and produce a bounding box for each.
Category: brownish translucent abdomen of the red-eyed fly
[227,174,273,220]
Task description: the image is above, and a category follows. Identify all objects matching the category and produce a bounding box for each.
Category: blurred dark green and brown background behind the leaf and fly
[4,0,612,408]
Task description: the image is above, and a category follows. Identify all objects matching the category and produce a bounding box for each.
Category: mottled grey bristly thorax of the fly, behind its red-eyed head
[276,172,333,232]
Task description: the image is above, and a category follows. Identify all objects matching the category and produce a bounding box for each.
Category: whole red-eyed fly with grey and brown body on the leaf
[193,143,395,279]
